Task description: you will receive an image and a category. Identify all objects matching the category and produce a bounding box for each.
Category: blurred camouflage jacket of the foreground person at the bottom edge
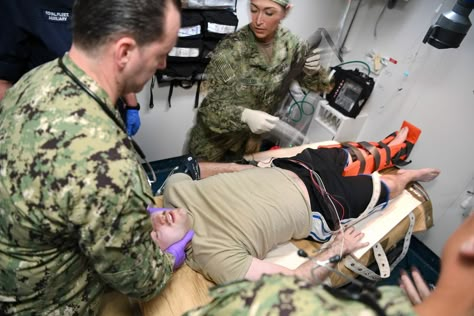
[185,275,416,316]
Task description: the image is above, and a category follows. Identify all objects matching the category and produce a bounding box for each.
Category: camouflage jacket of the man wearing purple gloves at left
[0,55,174,315]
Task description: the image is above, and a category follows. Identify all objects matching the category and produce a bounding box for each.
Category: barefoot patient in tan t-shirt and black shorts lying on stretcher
[149,123,440,284]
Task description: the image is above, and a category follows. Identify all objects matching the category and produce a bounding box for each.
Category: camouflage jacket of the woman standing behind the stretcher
[189,25,329,161]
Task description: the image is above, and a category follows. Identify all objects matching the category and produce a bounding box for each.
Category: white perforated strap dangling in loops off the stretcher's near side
[344,212,415,281]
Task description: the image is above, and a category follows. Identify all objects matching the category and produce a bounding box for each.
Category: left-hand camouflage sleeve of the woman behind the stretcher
[199,38,248,134]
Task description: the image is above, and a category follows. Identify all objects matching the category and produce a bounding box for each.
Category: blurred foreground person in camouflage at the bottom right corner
[186,214,474,316]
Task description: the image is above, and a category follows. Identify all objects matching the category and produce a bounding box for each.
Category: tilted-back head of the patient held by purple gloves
[151,208,191,250]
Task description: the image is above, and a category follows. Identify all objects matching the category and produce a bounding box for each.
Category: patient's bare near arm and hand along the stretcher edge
[245,228,367,283]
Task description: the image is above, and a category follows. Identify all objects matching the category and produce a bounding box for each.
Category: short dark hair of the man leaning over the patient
[72,0,181,49]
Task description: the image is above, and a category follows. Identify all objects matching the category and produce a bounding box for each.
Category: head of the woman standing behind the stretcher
[250,0,290,43]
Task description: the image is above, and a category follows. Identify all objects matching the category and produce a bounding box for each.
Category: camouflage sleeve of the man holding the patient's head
[70,144,174,300]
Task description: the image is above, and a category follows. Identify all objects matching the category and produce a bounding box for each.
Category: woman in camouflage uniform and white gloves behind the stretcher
[189,0,329,161]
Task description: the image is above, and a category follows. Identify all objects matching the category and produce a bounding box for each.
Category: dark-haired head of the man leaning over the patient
[70,0,181,97]
